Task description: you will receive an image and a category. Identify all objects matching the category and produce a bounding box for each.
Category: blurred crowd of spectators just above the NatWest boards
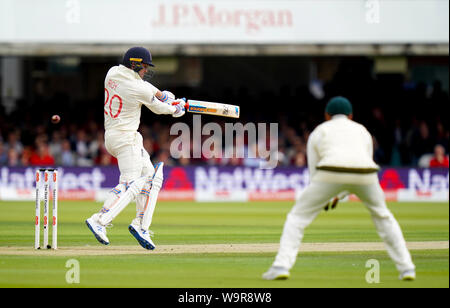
[0,98,449,167]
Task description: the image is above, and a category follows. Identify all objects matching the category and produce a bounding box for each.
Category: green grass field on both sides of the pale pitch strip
[0,201,449,288]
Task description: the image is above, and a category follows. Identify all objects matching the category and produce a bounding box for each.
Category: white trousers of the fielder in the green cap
[273,171,415,272]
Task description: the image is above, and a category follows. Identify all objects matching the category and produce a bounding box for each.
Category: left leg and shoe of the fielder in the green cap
[263,182,342,280]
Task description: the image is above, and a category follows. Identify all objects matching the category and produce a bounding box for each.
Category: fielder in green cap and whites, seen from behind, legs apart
[263,97,416,280]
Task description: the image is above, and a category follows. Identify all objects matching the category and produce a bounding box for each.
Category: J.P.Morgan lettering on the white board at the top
[151,2,293,34]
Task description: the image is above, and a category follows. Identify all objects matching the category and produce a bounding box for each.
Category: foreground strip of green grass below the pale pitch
[0,250,449,288]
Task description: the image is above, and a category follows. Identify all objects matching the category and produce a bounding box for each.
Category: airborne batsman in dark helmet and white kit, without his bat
[86,47,185,250]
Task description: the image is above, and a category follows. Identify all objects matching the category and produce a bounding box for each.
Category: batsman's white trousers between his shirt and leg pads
[105,131,155,184]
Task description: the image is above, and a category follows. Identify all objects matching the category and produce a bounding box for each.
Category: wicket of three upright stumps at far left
[34,168,58,249]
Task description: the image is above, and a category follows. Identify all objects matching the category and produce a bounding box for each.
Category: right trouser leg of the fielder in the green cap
[354,183,415,273]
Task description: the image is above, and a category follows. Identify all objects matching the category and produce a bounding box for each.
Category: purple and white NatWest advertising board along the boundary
[0,166,449,202]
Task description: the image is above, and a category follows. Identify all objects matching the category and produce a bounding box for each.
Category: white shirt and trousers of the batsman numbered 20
[104,65,175,183]
